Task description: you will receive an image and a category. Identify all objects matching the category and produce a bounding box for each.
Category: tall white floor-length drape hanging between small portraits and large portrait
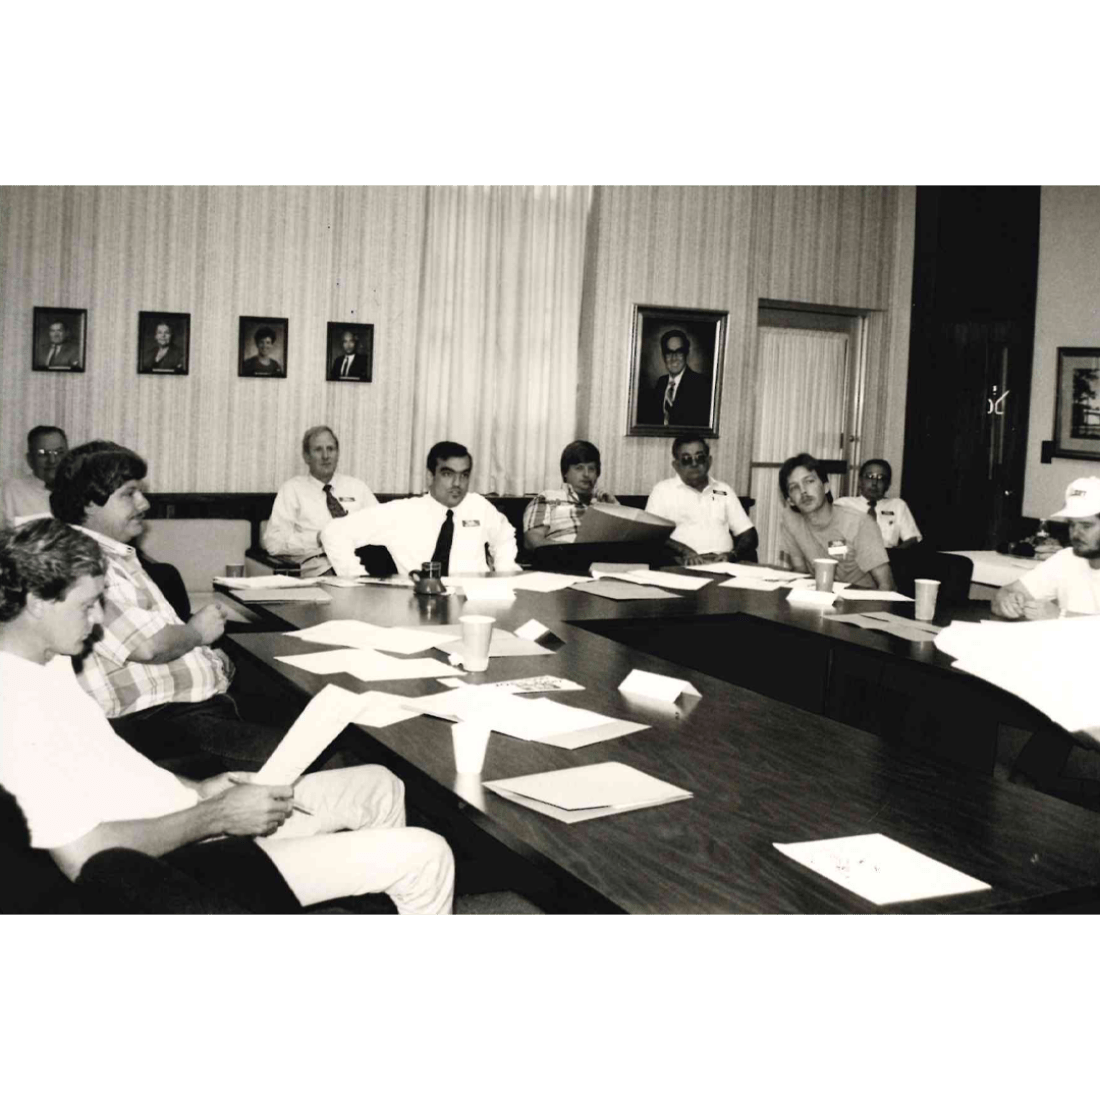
[411,186,592,494]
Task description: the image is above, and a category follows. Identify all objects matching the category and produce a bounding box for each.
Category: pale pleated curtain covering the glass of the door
[751,328,848,562]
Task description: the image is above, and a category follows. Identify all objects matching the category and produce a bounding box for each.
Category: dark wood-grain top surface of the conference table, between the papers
[218,584,1100,913]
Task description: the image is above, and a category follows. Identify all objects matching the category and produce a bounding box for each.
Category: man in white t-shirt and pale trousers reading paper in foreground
[0,519,454,914]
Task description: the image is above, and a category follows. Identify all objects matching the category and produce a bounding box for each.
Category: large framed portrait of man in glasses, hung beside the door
[627,306,729,436]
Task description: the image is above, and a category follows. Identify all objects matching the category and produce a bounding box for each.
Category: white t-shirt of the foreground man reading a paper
[0,653,198,848]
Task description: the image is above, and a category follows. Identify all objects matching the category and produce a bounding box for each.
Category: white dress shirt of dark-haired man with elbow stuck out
[321,493,516,576]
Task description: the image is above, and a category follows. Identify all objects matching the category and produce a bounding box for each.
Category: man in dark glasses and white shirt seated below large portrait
[646,435,758,565]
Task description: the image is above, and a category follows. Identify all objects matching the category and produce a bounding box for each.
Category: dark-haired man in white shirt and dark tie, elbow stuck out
[321,440,516,576]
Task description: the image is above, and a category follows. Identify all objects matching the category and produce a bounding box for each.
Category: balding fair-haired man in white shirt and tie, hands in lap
[263,425,378,576]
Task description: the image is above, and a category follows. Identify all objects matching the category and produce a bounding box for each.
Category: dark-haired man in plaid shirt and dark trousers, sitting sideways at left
[51,440,282,761]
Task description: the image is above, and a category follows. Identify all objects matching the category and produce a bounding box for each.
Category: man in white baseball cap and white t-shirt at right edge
[993,477,1100,618]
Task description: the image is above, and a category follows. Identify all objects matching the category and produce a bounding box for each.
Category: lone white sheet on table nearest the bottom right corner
[774,833,990,905]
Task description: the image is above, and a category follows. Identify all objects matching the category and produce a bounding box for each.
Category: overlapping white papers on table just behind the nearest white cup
[405,684,647,749]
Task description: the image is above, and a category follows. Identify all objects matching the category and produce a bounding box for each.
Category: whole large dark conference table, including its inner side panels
[216,574,1100,913]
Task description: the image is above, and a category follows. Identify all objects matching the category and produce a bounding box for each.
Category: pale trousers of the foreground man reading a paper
[256,765,454,915]
